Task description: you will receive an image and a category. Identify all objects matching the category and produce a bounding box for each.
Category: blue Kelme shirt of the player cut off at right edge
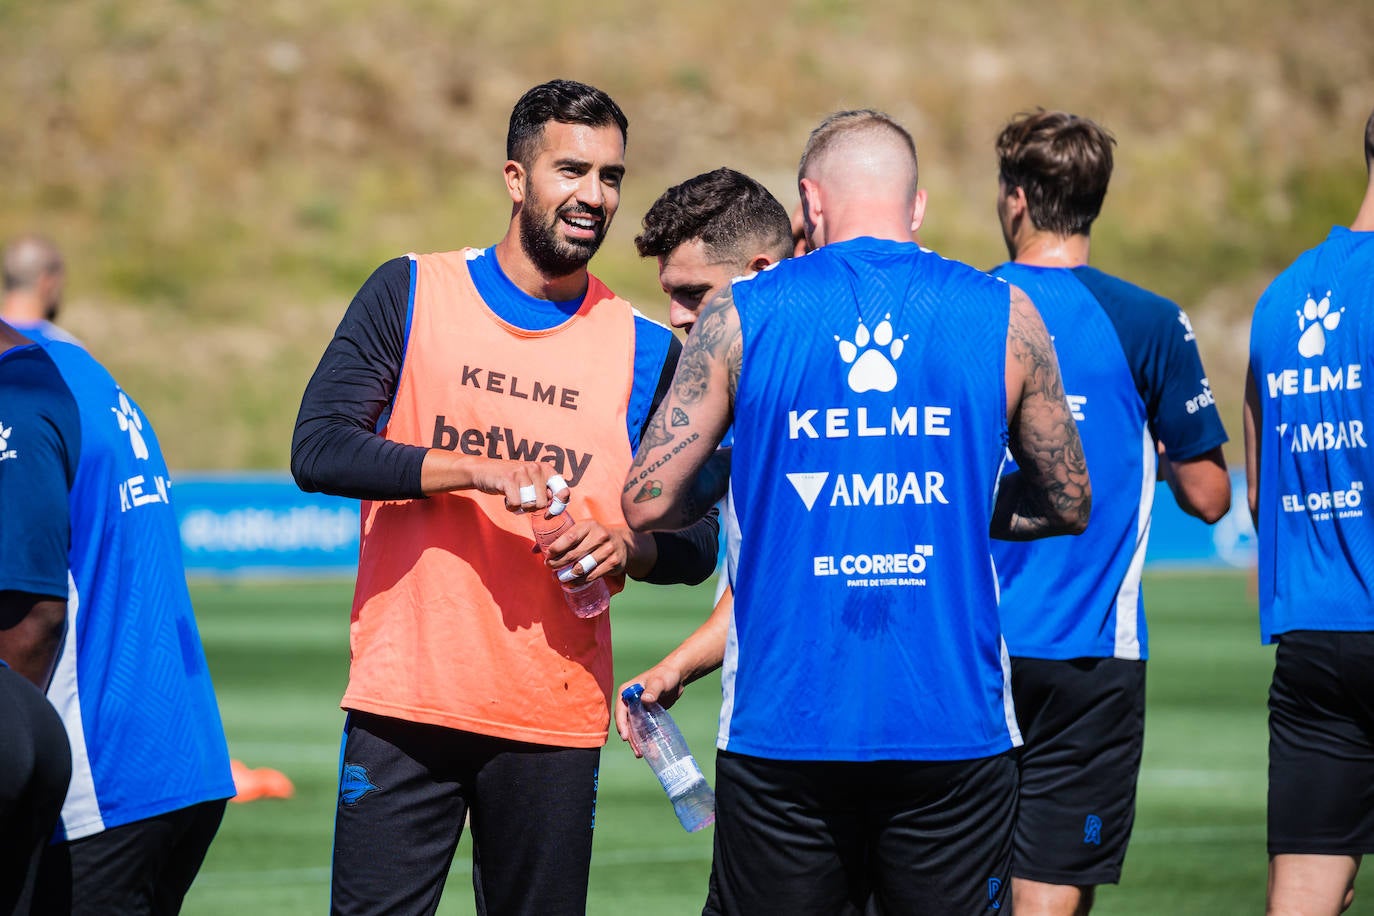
[1250,227,1374,643]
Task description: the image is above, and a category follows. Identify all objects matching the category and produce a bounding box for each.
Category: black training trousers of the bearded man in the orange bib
[331,711,600,916]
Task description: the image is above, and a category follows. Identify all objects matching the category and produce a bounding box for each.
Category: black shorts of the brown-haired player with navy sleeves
[1011,658,1145,887]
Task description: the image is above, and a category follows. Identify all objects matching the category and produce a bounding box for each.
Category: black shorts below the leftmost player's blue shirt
[33,799,225,916]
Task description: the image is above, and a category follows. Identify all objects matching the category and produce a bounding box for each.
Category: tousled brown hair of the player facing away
[998,108,1116,235]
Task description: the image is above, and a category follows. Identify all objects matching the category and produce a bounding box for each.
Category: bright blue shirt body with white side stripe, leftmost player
[45,342,234,839]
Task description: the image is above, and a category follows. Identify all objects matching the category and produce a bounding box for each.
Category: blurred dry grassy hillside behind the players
[0,0,1374,468]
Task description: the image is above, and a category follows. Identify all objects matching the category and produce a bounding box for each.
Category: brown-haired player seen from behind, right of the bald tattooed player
[992,110,1231,916]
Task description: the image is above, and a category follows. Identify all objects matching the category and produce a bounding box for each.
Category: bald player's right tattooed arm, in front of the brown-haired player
[992,287,1092,541]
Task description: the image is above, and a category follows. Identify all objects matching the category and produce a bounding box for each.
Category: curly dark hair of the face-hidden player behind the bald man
[635,168,791,261]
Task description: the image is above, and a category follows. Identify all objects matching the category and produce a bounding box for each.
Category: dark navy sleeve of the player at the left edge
[0,343,81,600]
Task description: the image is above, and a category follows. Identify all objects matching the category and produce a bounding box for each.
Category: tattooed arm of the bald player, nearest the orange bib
[620,287,743,531]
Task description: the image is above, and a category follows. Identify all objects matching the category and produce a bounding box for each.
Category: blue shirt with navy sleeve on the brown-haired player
[992,264,1226,659]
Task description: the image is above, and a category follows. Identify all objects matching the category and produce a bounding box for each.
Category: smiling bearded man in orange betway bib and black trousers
[291,80,719,915]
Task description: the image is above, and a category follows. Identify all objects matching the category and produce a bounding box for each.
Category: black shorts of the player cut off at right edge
[1268,630,1374,856]
